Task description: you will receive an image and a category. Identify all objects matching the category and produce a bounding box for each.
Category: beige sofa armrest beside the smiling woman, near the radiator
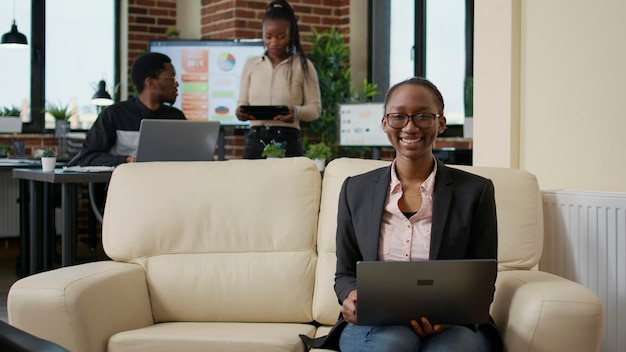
[491,270,604,352]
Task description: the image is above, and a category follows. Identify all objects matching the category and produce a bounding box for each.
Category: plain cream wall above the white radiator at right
[474,0,626,192]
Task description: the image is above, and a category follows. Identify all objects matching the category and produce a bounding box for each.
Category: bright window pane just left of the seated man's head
[45,0,115,130]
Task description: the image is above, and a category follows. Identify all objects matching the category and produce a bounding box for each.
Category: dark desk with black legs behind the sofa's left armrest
[13,168,112,276]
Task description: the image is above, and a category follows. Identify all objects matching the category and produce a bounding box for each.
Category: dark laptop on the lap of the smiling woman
[357,259,498,325]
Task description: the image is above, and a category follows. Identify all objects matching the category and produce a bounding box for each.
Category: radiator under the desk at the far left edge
[0,168,20,238]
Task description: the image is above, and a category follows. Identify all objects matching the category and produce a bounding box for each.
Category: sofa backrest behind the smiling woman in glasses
[313,158,543,325]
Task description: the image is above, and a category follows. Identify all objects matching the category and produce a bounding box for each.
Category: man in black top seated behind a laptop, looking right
[68,52,185,166]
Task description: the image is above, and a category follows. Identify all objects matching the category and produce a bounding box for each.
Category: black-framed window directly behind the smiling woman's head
[370,0,472,125]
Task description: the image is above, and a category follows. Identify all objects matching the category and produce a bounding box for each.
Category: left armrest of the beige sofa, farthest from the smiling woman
[7,261,154,352]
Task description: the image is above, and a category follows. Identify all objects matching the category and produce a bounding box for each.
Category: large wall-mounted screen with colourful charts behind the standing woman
[150,39,264,125]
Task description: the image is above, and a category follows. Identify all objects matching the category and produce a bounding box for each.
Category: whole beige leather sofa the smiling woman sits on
[8,158,603,352]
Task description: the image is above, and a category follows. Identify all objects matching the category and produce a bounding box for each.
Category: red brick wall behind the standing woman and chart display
[128,0,350,159]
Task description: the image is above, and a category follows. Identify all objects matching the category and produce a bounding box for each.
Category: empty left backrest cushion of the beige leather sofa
[102,157,321,323]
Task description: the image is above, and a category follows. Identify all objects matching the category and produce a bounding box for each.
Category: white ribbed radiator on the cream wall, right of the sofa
[539,190,626,352]
